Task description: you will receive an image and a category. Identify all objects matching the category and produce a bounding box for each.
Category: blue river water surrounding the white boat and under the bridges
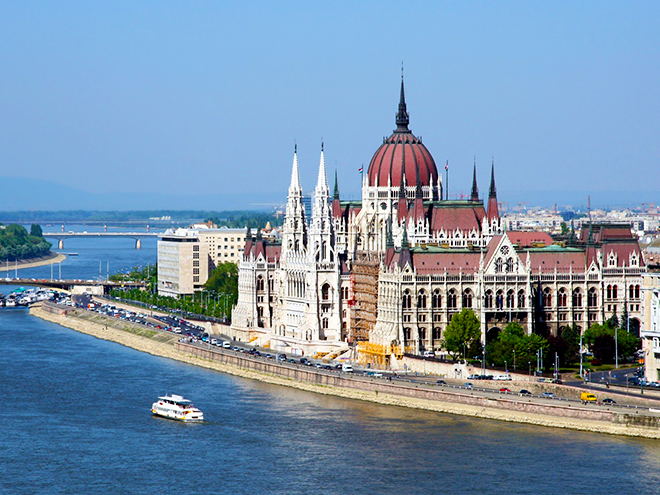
[0,229,660,494]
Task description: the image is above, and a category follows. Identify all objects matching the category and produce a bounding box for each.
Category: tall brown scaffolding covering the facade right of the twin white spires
[349,252,380,342]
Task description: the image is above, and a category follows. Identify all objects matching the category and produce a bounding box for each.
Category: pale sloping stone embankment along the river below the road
[30,304,660,438]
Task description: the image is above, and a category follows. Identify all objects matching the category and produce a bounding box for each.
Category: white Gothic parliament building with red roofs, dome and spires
[231,80,644,365]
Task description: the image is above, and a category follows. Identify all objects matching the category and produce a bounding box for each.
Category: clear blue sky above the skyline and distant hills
[0,1,660,209]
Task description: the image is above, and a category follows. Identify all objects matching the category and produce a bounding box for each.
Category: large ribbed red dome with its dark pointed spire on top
[367,79,438,188]
